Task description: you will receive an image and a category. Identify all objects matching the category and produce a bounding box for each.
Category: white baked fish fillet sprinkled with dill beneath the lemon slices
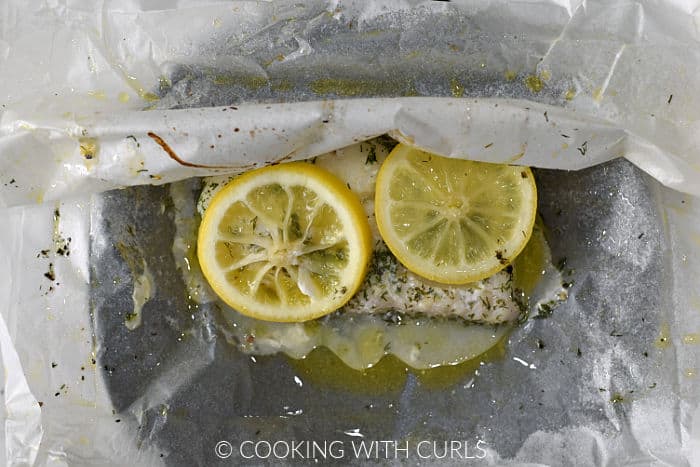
[197,138,520,324]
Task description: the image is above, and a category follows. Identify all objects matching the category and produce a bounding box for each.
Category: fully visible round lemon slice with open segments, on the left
[197,162,372,322]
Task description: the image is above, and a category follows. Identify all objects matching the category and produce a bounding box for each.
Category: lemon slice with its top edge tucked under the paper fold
[375,144,537,284]
